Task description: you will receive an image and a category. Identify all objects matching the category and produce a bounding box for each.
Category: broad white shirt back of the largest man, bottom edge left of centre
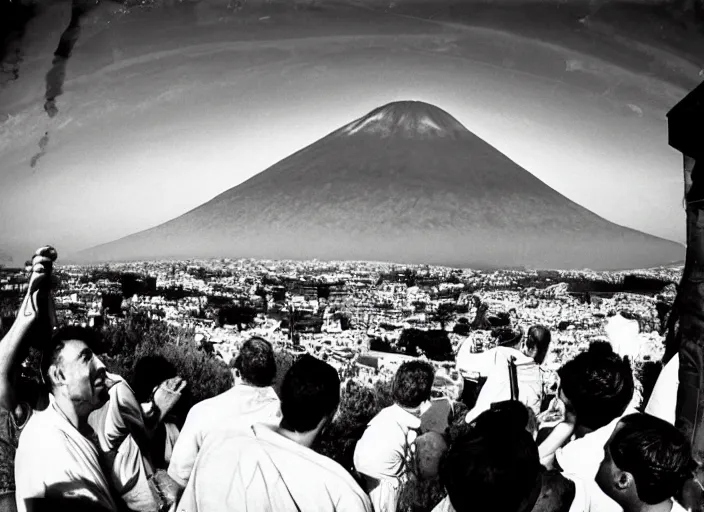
[176,424,372,512]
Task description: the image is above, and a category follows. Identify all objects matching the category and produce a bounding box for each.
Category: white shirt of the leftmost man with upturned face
[15,397,117,512]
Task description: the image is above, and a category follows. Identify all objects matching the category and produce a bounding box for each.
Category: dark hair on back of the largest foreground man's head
[281,354,340,432]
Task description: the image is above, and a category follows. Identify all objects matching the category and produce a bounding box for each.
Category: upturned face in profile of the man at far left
[58,340,108,409]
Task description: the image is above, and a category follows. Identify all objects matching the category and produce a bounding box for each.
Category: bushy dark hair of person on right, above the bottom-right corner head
[557,342,635,430]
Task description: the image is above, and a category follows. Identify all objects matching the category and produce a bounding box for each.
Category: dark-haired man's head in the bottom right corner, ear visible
[596,414,695,512]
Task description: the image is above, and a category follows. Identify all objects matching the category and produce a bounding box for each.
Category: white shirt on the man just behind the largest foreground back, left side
[168,384,281,487]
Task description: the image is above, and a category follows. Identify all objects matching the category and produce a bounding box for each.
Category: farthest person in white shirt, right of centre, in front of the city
[457,325,551,423]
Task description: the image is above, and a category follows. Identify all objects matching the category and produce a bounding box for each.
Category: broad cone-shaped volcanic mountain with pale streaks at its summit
[76,101,684,269]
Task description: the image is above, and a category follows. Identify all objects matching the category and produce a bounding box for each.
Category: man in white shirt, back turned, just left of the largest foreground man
[168,337,281,489]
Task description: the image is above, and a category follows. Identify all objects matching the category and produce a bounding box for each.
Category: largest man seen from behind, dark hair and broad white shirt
[176,355,372,512]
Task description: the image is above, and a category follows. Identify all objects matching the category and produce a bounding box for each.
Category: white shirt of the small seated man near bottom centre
[354,404,421,512]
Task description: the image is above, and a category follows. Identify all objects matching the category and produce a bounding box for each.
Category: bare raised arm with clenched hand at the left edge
[0,247,56,411]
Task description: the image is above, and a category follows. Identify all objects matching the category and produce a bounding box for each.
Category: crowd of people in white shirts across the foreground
[0,247,701,512]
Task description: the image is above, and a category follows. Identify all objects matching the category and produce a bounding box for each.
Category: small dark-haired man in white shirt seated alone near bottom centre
[354,360,435,512]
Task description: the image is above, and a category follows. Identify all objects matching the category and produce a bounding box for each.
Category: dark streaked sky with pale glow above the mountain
[0,0,704,258]
